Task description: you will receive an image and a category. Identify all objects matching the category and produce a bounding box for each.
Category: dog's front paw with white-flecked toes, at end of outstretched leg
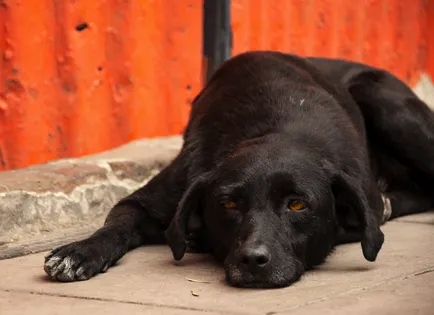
[44,240,109,282]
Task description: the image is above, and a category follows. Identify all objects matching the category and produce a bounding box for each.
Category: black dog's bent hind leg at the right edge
[348,70,434,218]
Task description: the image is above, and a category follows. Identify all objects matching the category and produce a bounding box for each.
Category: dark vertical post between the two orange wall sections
[203,0,232,82]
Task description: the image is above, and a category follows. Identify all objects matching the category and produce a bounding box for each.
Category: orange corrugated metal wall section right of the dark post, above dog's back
[232,0,434,84]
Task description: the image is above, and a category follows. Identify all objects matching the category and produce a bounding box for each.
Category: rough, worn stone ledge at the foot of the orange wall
[0,137,182,259]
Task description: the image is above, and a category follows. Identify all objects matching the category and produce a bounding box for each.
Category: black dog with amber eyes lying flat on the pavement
[44,52,434,287]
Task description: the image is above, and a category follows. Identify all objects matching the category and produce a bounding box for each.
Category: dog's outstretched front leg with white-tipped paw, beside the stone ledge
[44,153,187,281]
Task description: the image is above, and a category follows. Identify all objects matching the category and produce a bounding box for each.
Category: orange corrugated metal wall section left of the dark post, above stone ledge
[0,0,202,169]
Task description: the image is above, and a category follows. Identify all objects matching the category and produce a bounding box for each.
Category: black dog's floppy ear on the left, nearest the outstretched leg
[165,173,210,260]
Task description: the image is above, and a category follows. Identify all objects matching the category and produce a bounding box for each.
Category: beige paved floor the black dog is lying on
[0,212,434,315]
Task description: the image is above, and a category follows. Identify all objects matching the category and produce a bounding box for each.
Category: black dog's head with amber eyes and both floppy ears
[166,139,383,287]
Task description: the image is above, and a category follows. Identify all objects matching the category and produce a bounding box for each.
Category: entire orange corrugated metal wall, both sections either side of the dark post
[0,0,434,170]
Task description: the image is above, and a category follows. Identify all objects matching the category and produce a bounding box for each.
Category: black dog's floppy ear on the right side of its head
[331,163,384,261]
